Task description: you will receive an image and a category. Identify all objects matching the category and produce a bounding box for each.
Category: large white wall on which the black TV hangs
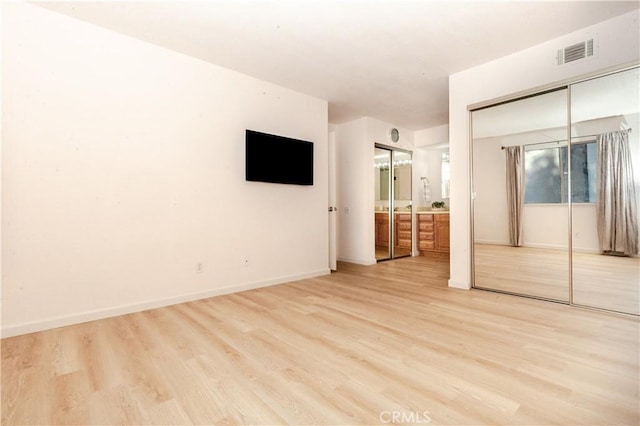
[2,3,329,336]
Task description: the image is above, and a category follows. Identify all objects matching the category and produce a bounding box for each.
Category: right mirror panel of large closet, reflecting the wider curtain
[570,68,640,315]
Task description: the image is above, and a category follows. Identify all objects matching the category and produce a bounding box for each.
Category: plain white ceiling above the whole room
[36,0,640,130]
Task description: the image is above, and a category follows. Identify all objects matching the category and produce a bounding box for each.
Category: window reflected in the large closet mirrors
[524,141,597,204]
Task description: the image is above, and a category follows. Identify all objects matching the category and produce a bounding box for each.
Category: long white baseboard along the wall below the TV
[1,268,331,338]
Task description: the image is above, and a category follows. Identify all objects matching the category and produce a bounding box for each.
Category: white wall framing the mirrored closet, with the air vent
[449,11,640,288]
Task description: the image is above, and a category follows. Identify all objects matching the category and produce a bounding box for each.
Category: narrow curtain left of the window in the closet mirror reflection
[505,146,524,247]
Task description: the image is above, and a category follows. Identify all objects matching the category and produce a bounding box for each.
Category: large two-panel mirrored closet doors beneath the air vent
[471,68,640,315]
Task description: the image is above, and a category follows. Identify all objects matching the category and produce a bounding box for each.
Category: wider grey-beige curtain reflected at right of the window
[596,131,638,255]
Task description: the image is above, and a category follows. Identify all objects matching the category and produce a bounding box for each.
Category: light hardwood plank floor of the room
[1,257,640,425]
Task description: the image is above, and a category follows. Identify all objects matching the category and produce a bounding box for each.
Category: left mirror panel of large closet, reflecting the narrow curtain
[471,89,570,302]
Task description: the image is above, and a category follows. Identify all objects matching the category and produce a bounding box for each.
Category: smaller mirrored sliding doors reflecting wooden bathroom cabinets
[374,144,413,261]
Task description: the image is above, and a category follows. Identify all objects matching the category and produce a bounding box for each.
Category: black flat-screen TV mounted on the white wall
[245,130,313,185]
